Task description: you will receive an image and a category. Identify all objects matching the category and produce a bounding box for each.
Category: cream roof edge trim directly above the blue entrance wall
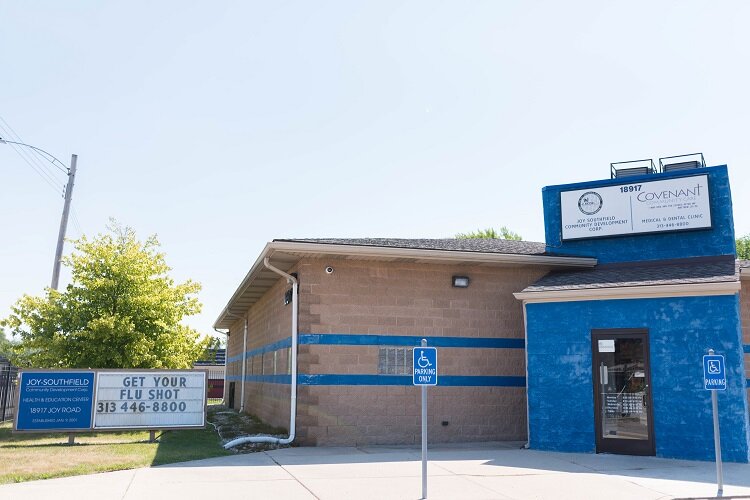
[513,281,740,304]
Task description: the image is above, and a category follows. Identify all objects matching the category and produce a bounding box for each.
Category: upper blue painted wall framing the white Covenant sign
[542,165,735,264]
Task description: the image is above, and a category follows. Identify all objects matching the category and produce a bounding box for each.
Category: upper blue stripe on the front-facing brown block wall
[299,333,524,349]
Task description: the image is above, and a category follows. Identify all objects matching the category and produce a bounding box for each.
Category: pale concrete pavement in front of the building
[0,443,750,500]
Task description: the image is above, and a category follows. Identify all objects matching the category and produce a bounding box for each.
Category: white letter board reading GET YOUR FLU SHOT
[93,370,206,429]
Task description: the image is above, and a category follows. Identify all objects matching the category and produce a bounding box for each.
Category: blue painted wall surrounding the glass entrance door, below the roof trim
[526,295,748,462]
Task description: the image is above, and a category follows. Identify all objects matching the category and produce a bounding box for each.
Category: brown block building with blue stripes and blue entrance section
[214,163,750,461]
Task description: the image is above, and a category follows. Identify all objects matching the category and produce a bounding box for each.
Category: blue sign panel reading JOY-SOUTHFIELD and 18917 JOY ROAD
[14,371,94,431]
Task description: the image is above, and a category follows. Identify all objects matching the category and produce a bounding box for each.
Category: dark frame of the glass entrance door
[591,328,656,456]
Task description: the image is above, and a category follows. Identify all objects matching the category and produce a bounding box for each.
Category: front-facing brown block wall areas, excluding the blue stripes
[298,259,547,445]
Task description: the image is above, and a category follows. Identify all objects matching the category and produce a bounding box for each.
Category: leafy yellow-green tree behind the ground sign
[0,222,209,368]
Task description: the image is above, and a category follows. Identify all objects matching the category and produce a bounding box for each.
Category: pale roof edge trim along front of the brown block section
[270,241,597,267]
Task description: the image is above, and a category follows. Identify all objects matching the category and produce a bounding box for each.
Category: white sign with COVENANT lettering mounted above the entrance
[560,175,711,241]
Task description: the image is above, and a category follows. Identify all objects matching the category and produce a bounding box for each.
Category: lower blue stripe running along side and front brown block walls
[227,373,526,387]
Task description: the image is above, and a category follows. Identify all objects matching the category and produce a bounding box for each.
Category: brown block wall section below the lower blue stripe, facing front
[297,386,526,446]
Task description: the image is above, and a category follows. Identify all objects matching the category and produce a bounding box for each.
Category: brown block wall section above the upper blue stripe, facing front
[299,259,548,338]
